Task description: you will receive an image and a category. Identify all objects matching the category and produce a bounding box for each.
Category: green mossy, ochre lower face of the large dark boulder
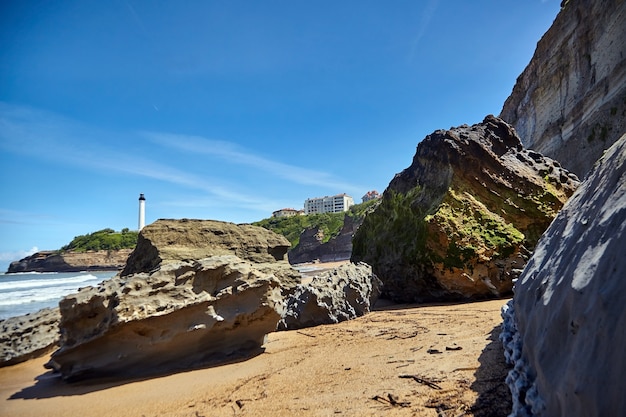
[352,187,525,271]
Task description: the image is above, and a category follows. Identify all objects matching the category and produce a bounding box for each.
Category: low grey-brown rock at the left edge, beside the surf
[0,308,61,367]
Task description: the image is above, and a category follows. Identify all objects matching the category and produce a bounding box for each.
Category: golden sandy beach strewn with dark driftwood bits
[0,300,510,417]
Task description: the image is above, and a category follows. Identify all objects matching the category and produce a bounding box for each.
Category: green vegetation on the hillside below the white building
[253,200,378,249]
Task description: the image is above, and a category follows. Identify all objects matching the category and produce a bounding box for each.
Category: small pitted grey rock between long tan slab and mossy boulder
[278,263,382,330]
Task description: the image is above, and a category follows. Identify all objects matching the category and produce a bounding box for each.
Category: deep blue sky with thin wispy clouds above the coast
[0,0,560,270]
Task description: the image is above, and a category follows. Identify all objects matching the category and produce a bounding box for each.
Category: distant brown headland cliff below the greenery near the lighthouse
[7,249,132,273]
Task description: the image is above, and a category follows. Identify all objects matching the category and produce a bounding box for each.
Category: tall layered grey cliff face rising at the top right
[500,0,626,177]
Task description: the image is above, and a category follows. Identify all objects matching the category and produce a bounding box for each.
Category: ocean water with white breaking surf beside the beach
[0,271,116,320]
